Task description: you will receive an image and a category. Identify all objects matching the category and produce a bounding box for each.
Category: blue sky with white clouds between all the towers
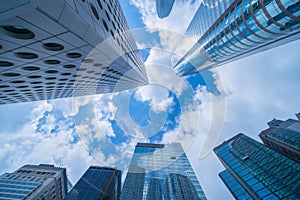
[0,0,300,199]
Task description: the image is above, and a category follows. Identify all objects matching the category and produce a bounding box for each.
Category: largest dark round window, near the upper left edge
[1,25,34,40]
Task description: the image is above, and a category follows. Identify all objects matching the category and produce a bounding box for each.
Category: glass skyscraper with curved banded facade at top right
[174,0,300,76]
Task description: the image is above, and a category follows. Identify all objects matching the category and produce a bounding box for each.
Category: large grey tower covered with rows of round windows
[0,0,148,104]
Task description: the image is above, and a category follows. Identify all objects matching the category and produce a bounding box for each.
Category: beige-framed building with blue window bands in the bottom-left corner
[0,164,67,200]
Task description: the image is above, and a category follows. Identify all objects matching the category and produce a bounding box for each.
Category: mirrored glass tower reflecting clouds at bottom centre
[120,143,206,200]
